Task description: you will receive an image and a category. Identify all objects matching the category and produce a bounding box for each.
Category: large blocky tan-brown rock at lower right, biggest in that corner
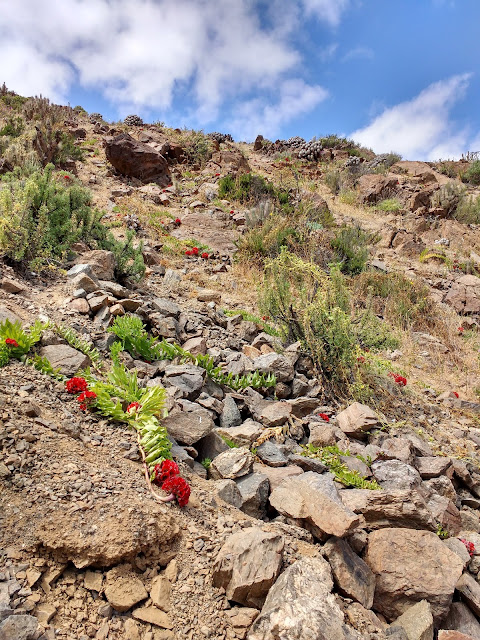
[365,529,463,623]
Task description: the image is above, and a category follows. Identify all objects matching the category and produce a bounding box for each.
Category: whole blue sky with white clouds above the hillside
[0,0,480,159]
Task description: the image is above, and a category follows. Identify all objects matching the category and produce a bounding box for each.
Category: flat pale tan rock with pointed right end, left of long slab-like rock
[270,471,360,539]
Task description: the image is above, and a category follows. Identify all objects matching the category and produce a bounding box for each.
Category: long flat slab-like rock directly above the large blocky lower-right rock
[340,489,437,531]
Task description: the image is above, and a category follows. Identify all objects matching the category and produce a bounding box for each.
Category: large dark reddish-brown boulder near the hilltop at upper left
[105,133,171,187]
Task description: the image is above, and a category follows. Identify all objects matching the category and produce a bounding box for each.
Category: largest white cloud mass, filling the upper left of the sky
[0,0,342,134]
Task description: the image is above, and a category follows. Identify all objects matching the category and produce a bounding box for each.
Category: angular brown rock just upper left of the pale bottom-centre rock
[213,527,285,609]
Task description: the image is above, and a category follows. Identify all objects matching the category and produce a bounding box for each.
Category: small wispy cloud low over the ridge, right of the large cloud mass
[229,80,328,140]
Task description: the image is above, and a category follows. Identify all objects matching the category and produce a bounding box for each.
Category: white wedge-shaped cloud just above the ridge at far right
[350,73,472,160]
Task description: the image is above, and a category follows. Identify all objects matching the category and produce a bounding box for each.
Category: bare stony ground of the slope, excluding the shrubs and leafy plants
[0,106,480,640]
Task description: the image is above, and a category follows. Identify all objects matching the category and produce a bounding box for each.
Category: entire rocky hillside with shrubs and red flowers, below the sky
[0,87,480,640]
